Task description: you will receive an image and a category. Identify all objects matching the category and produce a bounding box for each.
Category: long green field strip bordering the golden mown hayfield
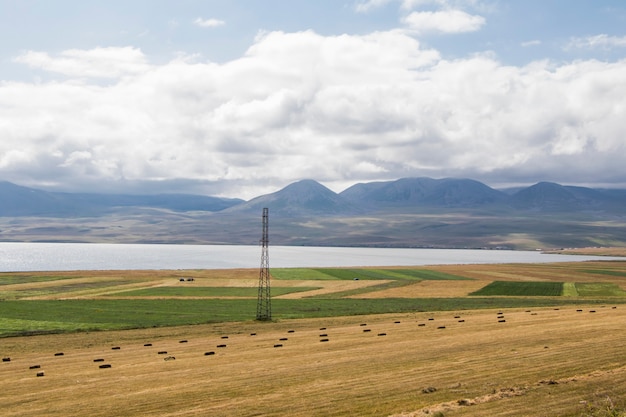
[0,297,620,337]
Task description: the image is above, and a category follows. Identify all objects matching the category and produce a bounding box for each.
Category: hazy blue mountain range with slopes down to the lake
[0,178,626,249]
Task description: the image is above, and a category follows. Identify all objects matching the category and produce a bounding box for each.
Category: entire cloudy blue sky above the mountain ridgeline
[0,0,626,199]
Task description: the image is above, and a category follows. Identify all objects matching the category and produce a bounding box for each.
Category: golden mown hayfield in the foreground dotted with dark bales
[0,307,626,416]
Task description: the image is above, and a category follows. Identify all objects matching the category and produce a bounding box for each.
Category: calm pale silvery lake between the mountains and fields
[0,242,623,272]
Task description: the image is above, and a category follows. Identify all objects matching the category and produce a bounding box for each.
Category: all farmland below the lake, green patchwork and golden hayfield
[0,262,626,417]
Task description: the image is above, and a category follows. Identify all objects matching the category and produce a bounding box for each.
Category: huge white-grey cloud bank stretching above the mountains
[0,31,626,198]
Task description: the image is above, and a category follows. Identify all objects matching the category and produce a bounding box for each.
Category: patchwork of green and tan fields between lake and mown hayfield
[0,262,626,337]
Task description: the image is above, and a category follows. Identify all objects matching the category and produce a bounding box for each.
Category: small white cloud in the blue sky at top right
[402,10,486,33]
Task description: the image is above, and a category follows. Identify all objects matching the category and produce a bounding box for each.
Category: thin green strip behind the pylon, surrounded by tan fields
[109,287,321,297]
